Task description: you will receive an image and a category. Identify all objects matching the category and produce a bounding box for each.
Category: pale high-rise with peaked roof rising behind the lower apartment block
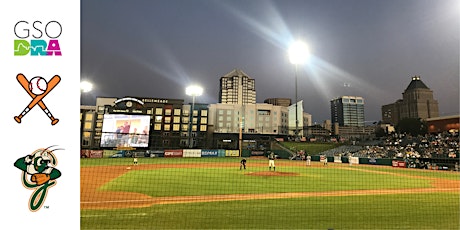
[219,69,256,105]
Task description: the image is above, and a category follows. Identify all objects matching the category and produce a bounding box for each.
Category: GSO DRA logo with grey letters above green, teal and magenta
[14,21,62,56]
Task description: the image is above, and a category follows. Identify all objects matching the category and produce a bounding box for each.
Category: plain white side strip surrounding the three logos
[0,0,80,229]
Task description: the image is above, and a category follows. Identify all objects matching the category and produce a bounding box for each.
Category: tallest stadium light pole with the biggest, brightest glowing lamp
[289,41,310,141]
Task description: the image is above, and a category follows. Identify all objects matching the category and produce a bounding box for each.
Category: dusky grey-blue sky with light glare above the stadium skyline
[81,0,460,123]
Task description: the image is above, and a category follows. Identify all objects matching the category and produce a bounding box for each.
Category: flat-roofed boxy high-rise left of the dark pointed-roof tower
[331,96,364,126]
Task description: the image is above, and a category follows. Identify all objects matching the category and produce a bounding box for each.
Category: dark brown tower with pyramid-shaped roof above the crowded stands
[382,76,439,124]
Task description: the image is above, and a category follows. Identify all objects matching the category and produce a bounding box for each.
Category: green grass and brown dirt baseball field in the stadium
[81,157,460,229]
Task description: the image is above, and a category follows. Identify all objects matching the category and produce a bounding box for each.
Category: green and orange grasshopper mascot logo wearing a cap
[14,146,61,212]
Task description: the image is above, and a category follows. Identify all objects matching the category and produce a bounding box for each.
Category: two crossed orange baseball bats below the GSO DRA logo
[14,74,61,125]
